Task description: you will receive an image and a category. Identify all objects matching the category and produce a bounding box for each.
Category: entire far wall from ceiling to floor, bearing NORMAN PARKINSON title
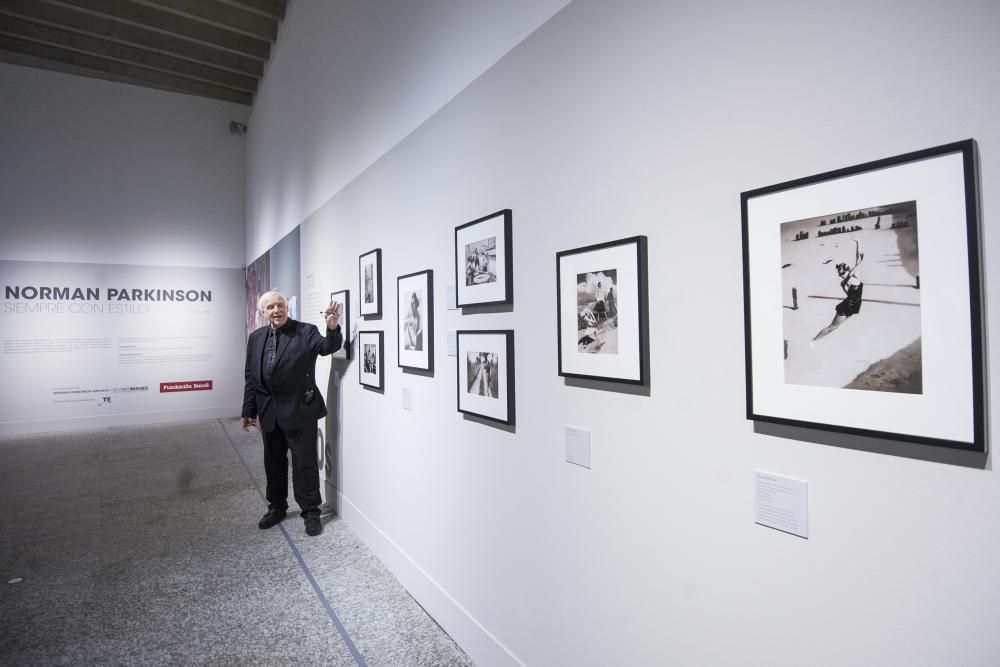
[0,64,248,433]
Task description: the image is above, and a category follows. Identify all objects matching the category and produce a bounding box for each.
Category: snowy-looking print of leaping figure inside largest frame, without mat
[781,201,923,394]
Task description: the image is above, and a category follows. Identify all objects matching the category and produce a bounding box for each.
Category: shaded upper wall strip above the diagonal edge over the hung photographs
[246,0,569,262]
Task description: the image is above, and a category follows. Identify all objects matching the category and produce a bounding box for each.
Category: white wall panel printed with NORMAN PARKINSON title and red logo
[0,261,246,434]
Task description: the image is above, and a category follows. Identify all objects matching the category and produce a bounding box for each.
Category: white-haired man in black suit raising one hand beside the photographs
[241,290,344,536]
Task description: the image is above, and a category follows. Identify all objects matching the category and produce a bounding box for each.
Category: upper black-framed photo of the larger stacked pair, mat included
[455,208,514,308]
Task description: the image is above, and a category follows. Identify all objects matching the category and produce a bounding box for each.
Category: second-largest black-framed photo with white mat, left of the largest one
[556,236,649,384]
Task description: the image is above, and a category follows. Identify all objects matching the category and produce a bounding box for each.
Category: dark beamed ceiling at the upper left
[0,0,285,105]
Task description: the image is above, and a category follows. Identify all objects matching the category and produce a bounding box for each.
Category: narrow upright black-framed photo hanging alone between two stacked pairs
[396,269,434,371]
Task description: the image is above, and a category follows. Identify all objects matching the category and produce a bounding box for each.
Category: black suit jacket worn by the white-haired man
[242,319,344,431]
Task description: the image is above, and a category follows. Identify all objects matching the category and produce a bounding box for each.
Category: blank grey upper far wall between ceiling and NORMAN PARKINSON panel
[0,64,249,268]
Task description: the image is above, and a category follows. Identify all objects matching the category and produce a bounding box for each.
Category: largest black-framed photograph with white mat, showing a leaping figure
[741,140,986,451]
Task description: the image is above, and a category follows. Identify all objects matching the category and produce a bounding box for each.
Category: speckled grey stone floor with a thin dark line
[0,420,472,667]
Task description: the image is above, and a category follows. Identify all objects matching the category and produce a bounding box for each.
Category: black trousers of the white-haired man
[262,422,323,516]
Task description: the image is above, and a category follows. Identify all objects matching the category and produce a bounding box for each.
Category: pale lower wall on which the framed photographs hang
[248,0,1000,665]
